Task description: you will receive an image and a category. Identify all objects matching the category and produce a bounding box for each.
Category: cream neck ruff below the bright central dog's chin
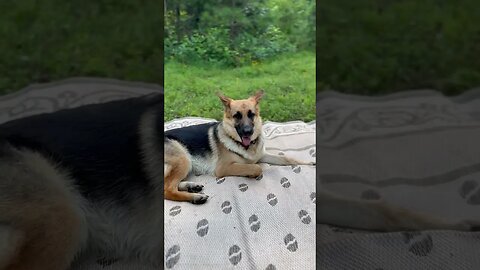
[217,123,263,162]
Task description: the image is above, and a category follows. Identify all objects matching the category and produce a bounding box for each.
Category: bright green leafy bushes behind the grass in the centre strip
[165,0,315,66]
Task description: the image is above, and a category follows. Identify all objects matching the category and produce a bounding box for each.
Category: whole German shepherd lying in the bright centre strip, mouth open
[164,90,314,204]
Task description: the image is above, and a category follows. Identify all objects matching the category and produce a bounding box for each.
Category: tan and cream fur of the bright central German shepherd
[164,91,313,202]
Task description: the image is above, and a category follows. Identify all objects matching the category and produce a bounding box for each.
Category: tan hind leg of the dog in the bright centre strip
[164,140,208,204]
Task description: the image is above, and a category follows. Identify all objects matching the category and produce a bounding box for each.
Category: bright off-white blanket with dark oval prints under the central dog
[165,118,315,270]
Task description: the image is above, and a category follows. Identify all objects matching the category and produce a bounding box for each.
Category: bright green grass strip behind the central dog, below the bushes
[165,52,315,122]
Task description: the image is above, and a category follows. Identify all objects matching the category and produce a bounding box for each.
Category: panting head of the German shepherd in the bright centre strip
[217,90,263,148]
